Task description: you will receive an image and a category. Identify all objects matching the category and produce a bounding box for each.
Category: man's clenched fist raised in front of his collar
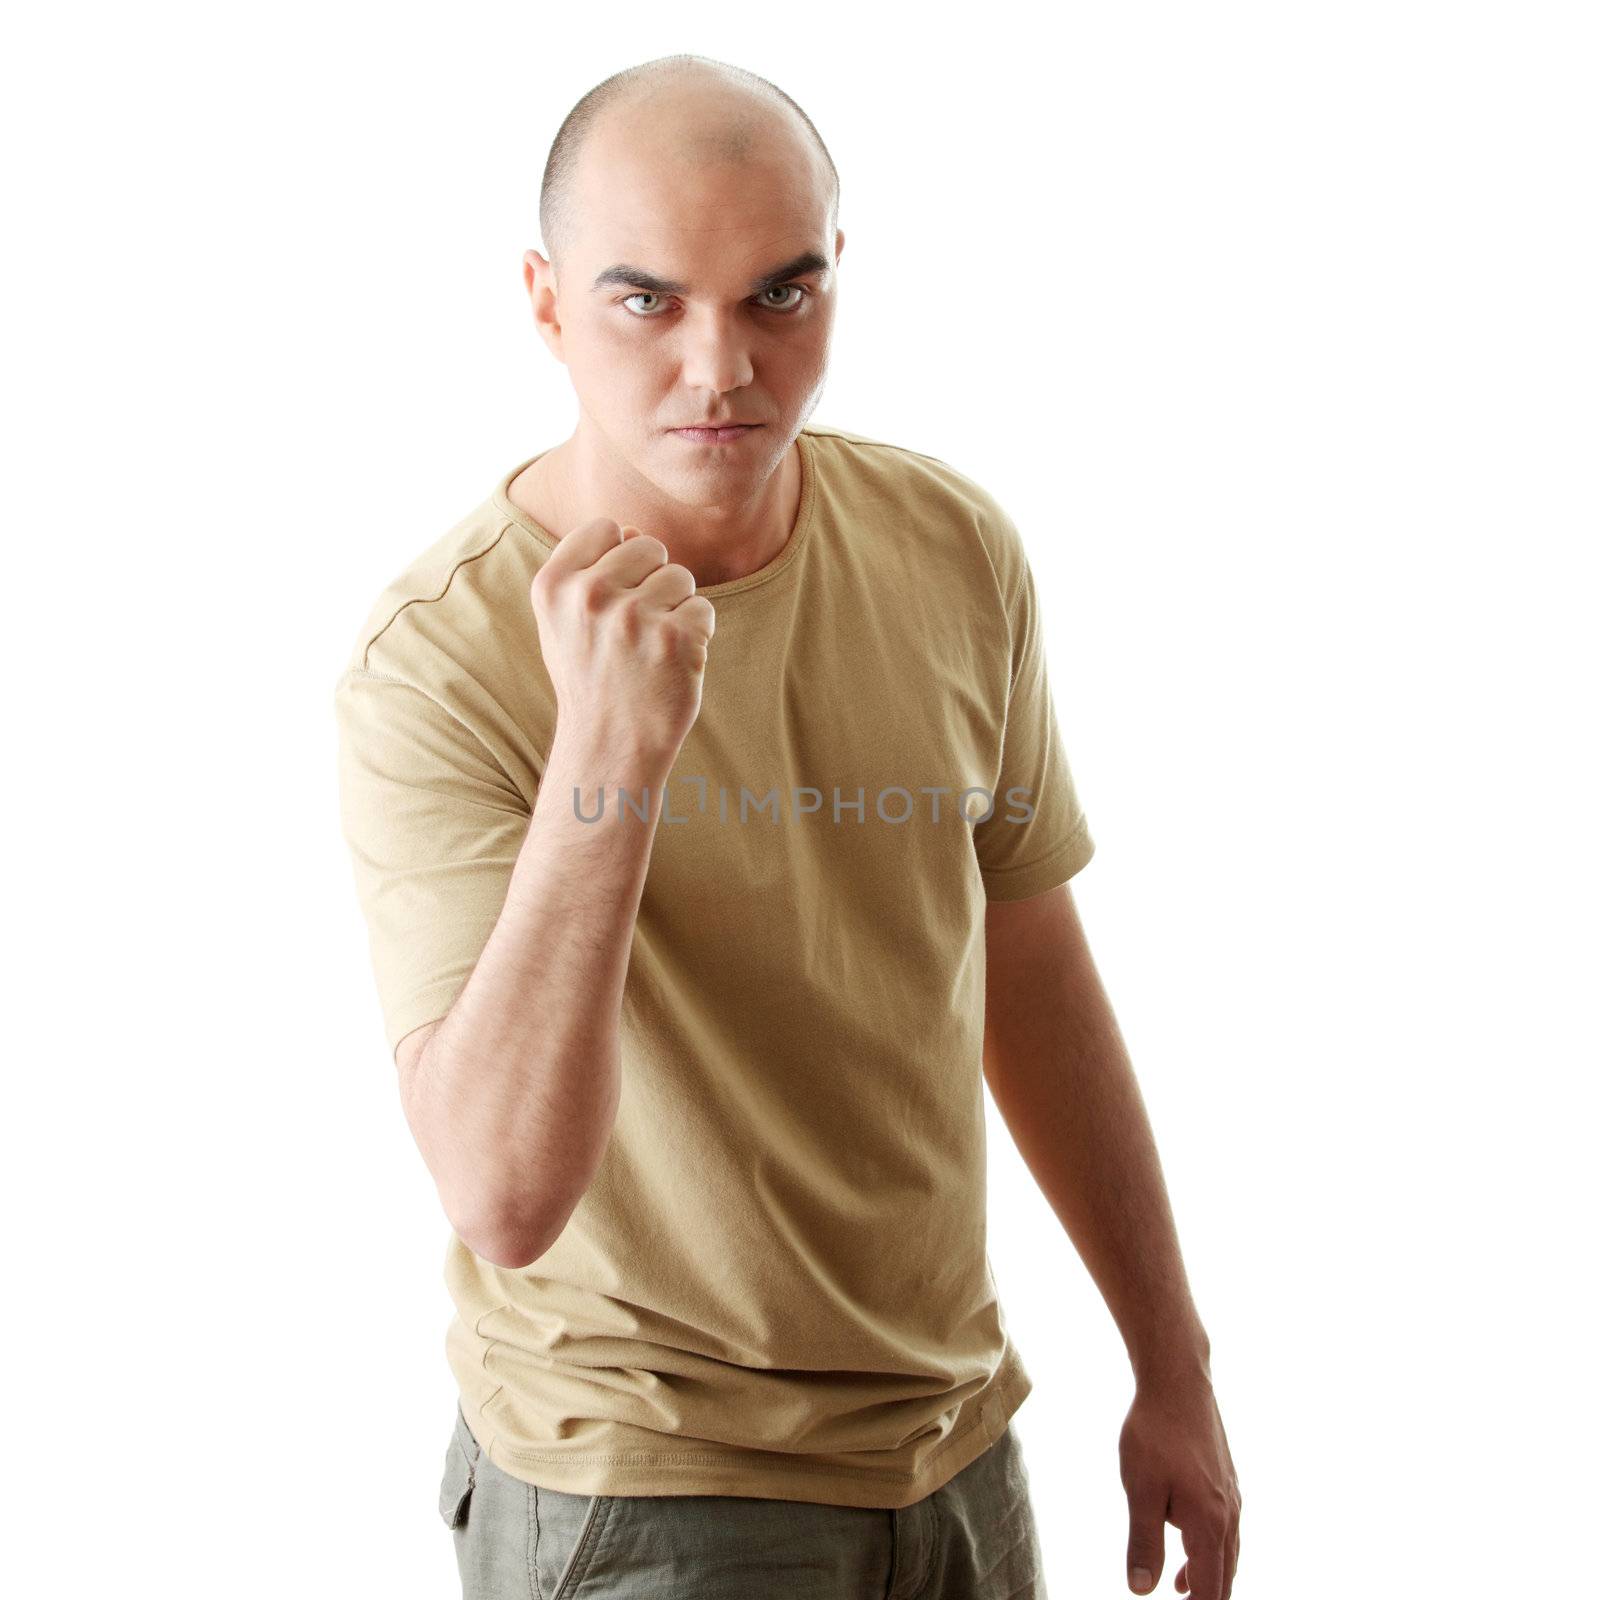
[531,517,717,760]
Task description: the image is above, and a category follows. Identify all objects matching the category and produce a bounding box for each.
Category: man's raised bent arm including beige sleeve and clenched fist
[336,517,717,1267]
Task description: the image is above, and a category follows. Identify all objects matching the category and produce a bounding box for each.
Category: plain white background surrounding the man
[0,0,1600,1600]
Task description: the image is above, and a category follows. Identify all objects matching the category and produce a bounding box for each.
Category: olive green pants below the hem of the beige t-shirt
[438,1405,1046,1600]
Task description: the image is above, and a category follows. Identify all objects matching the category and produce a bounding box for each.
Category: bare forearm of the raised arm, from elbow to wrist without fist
[408,725,672,1259]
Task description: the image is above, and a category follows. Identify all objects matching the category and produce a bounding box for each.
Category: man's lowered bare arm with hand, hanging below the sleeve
[984,883,1240,1600]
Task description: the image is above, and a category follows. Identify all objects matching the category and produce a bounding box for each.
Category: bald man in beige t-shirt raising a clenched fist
[336,56,1238,1600]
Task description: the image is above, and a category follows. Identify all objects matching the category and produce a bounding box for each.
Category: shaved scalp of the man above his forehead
[539,54,838,277]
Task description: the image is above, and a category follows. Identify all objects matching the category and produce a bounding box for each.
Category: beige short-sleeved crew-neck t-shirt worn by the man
[336,424,1094,1507]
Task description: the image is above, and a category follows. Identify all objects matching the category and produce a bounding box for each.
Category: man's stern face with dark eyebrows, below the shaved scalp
[526,108,843,506]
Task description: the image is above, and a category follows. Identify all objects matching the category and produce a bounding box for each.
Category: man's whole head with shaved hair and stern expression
[523,56,845,506]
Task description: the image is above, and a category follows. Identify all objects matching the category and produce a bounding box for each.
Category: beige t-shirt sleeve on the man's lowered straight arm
[973,506,1094,901]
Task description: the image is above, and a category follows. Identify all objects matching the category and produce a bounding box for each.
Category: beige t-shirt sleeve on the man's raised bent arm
[334,669,531,1051]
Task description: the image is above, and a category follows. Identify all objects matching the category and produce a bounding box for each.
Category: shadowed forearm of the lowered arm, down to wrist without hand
[984,947,1210,1382]
